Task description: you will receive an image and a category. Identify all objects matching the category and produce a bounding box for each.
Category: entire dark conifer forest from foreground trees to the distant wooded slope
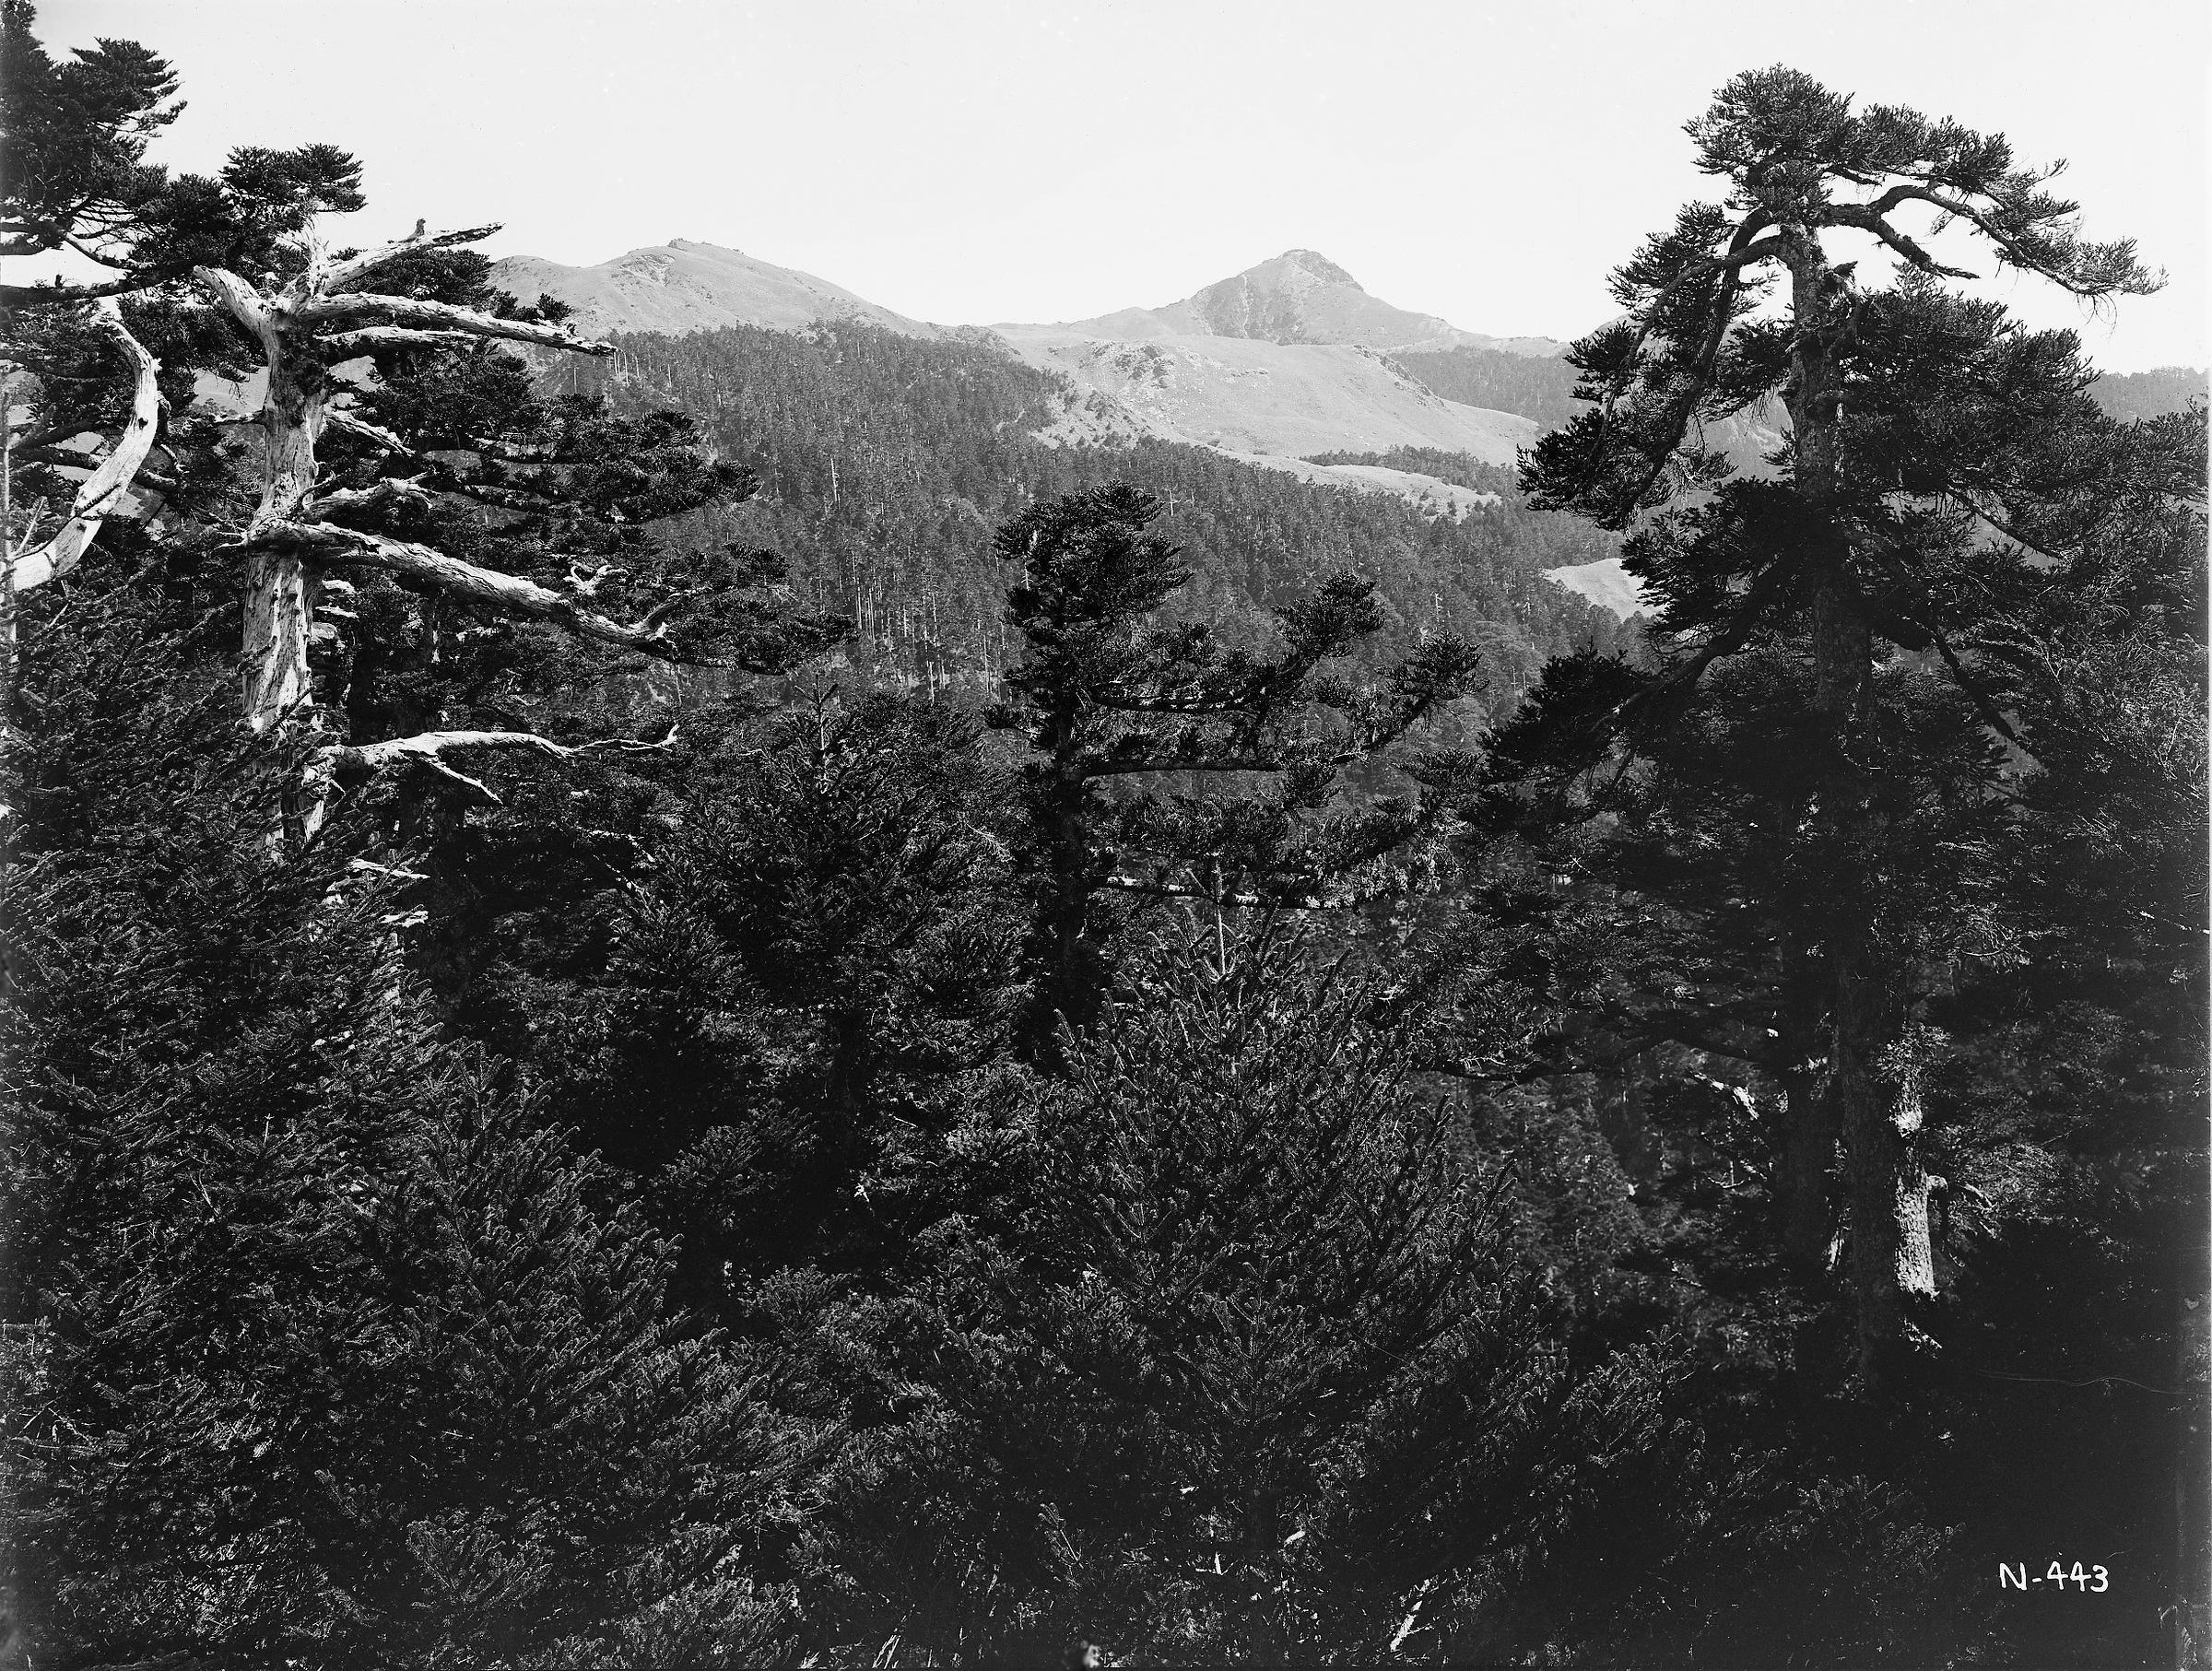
[0,0,2212,1671]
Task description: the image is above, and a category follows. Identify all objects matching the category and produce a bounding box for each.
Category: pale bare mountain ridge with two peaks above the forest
[491,239,1632,630]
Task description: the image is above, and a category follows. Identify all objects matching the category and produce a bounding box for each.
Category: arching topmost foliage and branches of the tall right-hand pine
[1522,66,2163,529]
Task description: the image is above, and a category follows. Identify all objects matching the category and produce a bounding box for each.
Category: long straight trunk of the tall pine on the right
[1785,228,1936,1399]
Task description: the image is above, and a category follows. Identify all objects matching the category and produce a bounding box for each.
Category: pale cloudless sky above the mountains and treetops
[38,0,2212,371]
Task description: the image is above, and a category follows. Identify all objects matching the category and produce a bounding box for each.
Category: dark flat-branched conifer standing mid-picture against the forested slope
[991,482,1476,1020]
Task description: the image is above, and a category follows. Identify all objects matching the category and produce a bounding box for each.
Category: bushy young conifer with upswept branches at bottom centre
[805,923,1661,1662]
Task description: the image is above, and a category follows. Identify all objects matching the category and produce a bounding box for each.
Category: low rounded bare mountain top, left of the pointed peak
[491,239,942,336]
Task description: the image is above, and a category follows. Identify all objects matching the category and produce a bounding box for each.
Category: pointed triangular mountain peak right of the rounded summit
[1048,250,1561,359]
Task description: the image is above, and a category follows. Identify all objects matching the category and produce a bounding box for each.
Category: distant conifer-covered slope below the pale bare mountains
[579,324,1621,712]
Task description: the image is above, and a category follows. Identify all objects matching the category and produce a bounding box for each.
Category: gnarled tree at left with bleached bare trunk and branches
[9,117,831,843]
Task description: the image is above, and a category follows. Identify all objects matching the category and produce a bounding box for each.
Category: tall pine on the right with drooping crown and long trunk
[1522,66,2201,1396]
